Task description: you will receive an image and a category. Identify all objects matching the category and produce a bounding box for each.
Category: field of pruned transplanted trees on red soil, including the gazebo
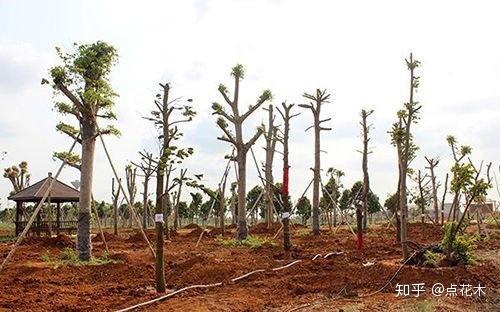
[0,41,500,311]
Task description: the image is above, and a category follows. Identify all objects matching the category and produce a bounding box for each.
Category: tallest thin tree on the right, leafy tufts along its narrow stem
[390,53,421,259]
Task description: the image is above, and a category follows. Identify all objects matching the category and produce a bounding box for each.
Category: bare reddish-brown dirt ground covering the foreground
[0,224,500,311]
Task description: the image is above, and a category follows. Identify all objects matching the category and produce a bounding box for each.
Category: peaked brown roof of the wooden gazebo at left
[8,172,80,203]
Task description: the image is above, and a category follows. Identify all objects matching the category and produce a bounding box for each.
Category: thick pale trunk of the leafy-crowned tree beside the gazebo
[76,121,96,261]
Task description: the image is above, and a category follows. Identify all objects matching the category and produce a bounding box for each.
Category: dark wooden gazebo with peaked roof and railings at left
[8,172,80,236]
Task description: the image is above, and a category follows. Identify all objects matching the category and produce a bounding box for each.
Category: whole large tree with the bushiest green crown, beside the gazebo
[42,41,119,261]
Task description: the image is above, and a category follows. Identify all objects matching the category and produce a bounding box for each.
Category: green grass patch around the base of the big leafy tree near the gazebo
[40,247,121,268]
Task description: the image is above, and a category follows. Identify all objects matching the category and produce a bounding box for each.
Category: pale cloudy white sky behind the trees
[0,0,500,209]
